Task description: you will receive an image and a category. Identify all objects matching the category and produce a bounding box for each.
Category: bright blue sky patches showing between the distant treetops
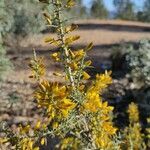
[83,0,144,11]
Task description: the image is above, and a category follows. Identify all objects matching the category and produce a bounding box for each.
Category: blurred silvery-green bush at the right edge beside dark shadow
[126,40,150,86]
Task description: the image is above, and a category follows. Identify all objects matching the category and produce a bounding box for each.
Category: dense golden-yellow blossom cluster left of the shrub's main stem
[35,81,75,119]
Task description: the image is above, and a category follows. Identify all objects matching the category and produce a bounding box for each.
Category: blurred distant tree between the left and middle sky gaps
[90,0,108,19]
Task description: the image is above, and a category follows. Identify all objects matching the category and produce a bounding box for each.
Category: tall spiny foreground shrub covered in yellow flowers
[0,0,148,150]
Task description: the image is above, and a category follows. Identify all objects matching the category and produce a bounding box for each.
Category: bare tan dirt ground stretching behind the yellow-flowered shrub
[0,20,150,129]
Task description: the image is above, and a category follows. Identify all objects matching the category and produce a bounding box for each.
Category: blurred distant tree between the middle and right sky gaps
[113,0,136,20]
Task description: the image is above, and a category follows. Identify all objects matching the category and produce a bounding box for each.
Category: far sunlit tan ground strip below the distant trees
[22,20,150,47]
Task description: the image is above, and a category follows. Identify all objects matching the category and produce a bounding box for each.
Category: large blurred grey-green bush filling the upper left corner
[0,0,44,43]
